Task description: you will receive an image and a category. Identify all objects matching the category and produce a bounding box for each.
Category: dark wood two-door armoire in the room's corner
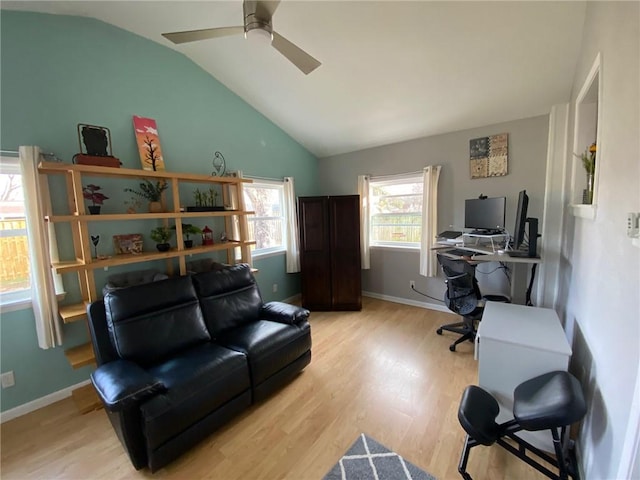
[298,195,362,310]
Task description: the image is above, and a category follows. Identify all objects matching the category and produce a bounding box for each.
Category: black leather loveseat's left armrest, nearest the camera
[91,360,165,412]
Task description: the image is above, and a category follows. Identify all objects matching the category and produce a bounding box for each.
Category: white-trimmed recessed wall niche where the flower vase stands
[570,53,603,220]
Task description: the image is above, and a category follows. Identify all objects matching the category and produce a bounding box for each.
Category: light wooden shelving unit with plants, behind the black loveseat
[38,162,255,413]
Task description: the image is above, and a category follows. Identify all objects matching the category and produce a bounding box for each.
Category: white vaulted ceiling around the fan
[2,0,585,157]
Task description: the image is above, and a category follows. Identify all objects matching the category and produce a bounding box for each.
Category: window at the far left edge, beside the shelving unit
[0,157,31,305]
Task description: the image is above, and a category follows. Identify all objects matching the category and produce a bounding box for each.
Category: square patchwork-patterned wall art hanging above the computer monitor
[469,133,509,179]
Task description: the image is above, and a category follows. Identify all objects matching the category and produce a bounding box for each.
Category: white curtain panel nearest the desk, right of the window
[420,165,441,277]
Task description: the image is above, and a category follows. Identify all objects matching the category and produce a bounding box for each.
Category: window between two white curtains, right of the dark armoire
[369,174,423,248]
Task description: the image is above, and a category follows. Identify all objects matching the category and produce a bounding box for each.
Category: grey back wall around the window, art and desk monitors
[318,116,548,306]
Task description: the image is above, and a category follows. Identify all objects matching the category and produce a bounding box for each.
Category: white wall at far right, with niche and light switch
[559,2,640,480]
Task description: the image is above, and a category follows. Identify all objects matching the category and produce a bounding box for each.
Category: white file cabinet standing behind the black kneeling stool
[476,302,571,452]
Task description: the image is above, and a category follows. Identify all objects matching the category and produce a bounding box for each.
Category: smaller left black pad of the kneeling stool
[458,385,500,446]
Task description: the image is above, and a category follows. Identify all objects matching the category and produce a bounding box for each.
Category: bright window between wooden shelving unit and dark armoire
[244,180,285,257]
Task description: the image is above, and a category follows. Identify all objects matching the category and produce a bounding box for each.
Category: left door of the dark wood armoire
[298,197,331,310]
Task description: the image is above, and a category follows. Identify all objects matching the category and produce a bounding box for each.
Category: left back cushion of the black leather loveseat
[104,277,211,365]
